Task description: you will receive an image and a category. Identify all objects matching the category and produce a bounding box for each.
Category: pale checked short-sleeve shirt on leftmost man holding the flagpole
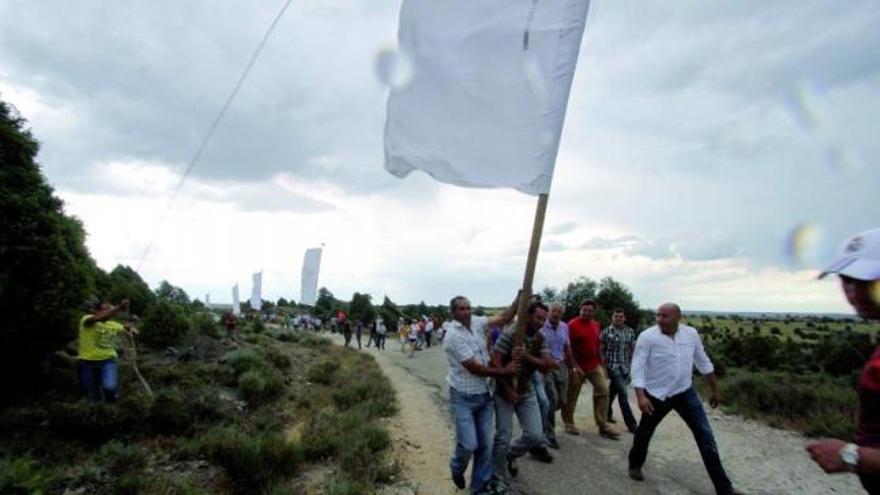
[443,316,489,395]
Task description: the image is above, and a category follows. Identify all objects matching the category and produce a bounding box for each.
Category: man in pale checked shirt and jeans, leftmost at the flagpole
[443,296,522,495]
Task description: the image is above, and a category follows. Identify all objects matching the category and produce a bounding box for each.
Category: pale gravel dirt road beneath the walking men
[330,341,861,495]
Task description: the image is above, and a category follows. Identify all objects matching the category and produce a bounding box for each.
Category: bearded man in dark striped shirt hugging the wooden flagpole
[492,301,555,493]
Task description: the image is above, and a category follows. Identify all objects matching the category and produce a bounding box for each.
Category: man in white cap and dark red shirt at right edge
[807,228,880,493]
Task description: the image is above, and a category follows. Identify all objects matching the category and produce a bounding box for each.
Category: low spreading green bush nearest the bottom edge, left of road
[187,426,303,491]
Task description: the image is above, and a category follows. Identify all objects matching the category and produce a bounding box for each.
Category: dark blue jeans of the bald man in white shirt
[629,387,733,495]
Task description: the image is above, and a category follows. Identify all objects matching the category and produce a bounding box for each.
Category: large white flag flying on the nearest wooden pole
[385,0,590,195]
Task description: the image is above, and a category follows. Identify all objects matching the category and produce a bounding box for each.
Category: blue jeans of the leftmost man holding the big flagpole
[449,387,492,494]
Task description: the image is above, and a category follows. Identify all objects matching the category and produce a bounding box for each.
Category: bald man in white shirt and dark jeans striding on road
[629,303,737,495]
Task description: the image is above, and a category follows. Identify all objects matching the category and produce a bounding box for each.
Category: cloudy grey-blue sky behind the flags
[0,0,880,312]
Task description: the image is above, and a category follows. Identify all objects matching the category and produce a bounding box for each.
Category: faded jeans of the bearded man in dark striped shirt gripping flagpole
[492,392,547,486]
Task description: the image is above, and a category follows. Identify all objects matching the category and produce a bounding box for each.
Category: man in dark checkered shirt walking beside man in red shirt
[599,308,638,433]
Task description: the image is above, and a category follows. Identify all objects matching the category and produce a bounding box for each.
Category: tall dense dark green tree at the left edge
[0,101,97,398]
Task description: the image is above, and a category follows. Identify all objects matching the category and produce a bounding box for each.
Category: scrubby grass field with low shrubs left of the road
[0,329,397,494]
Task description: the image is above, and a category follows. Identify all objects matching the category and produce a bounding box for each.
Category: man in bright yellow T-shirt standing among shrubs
[77,299,138,403]
